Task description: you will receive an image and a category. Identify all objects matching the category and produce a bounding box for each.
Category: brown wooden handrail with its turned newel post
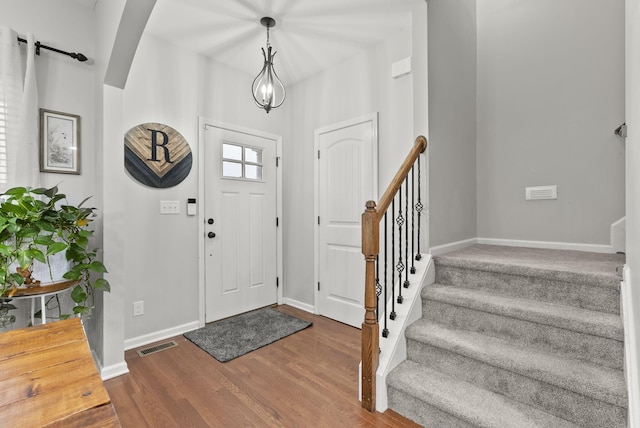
[361,135,427,412]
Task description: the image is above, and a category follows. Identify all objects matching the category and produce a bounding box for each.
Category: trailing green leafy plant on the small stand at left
[0,186,110,326]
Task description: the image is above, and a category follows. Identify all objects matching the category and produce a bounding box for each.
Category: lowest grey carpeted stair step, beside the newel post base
[387,361,577,428]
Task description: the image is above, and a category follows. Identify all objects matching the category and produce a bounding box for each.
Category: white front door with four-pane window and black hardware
[204,126,277,322]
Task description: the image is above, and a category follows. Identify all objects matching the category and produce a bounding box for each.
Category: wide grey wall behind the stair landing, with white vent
[477,0,624,245]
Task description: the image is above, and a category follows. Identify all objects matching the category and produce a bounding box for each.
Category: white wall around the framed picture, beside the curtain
[0,0,101,328]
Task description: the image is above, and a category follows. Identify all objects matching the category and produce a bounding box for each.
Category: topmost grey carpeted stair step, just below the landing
[434,245,624,314]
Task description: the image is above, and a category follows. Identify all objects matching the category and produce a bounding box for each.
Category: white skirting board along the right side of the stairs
[620,265,640,428]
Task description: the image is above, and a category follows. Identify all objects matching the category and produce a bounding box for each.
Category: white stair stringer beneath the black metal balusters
[372,254,436,412]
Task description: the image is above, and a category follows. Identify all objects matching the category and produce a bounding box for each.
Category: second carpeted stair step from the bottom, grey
[404,319,626,428]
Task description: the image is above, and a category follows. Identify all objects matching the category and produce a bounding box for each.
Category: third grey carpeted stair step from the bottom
[422,284,624,370]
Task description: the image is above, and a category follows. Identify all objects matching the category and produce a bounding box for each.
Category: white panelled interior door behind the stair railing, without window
[315,115,378,327]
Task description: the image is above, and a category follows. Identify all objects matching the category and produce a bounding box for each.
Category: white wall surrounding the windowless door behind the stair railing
[283,15,415,306]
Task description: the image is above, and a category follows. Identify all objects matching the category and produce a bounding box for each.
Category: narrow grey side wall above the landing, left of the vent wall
[428,0,477,246]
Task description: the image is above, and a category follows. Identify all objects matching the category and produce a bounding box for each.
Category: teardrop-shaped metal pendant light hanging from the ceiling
[251,16,286,113]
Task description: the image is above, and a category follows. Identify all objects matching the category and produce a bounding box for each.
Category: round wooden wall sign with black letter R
[124,123,193,188]
